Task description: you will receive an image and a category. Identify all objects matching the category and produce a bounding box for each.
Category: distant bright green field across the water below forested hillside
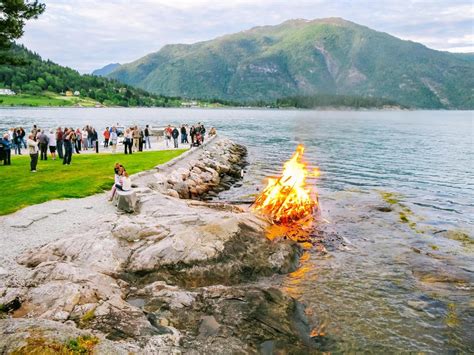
[0,92,98,107]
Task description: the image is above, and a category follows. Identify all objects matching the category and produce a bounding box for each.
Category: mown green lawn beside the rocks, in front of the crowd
[0,149,185,215]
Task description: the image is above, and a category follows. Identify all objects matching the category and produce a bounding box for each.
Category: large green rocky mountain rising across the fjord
[108,18,474,109]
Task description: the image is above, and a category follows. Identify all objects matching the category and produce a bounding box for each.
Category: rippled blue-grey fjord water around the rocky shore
[0,108,474,352]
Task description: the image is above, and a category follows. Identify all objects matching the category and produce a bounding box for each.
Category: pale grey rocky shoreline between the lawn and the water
[0,137,318,354]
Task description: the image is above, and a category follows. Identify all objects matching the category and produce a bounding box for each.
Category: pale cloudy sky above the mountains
[19,0,474,73]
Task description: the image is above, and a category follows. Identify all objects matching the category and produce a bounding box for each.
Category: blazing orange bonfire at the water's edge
[252,145,319,224]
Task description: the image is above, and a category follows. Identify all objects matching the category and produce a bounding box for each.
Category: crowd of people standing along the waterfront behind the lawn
[0,122,216,172]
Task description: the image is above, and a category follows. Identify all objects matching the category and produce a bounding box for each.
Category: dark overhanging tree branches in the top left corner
[0,0,45,64]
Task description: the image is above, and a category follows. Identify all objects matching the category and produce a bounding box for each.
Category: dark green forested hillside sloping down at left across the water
[0,44,181,106]
